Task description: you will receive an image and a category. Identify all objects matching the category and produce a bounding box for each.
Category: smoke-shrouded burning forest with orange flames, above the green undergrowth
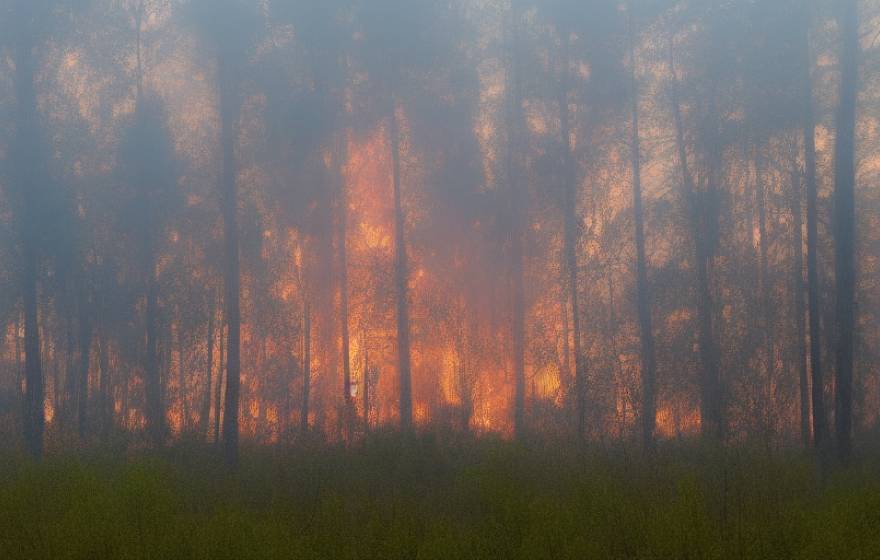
[0,0,880,464]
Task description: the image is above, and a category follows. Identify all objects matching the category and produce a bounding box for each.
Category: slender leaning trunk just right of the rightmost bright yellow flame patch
[557,31,587,441]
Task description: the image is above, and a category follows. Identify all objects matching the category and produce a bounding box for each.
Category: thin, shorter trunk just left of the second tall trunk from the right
[790,171,810,448]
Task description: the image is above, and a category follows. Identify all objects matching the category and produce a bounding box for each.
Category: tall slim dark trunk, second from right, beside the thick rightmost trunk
[801,1,829,452]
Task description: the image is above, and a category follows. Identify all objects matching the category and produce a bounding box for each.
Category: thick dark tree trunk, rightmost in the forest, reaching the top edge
[834,0,859,462]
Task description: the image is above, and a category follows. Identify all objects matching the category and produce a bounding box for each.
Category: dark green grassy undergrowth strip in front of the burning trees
[0,434,880,560]
